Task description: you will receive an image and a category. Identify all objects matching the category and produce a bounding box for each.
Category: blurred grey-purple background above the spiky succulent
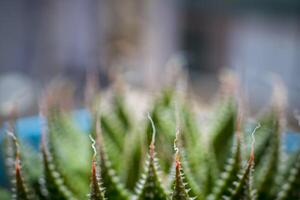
[0,0,300,130]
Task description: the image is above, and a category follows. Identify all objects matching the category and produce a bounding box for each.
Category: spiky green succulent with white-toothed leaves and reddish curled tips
[0,90,300,200]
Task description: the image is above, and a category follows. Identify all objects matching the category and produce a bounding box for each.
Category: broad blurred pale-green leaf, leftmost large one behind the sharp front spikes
[48,111,91,199]
